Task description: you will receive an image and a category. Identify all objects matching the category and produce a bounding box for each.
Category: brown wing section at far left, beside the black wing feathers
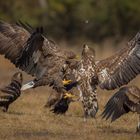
[0,21,30,63]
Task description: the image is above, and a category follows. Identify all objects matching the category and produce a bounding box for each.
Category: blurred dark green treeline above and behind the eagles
[0,0,140,43]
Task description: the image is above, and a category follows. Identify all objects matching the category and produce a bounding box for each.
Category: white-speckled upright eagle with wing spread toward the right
[62,33,140,116]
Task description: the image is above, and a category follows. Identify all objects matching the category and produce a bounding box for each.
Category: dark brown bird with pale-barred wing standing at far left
[0,72,23,112]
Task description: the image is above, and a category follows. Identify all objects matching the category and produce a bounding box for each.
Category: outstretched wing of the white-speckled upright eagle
[96,33,140,90]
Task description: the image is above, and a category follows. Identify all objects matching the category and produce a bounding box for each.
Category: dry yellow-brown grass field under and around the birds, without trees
[0,43,140,140]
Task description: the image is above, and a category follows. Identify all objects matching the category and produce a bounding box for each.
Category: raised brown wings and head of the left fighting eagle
[0,22,75,78]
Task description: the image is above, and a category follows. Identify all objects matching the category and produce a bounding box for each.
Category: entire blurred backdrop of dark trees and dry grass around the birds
[0,0,140,140]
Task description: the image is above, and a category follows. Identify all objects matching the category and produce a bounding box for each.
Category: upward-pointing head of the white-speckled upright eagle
[82,44,95,59]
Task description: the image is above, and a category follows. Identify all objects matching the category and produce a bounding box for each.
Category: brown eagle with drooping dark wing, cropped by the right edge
[102,86,140,133]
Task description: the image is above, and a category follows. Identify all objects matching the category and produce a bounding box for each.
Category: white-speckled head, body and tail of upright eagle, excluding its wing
[72,45,98,118]
